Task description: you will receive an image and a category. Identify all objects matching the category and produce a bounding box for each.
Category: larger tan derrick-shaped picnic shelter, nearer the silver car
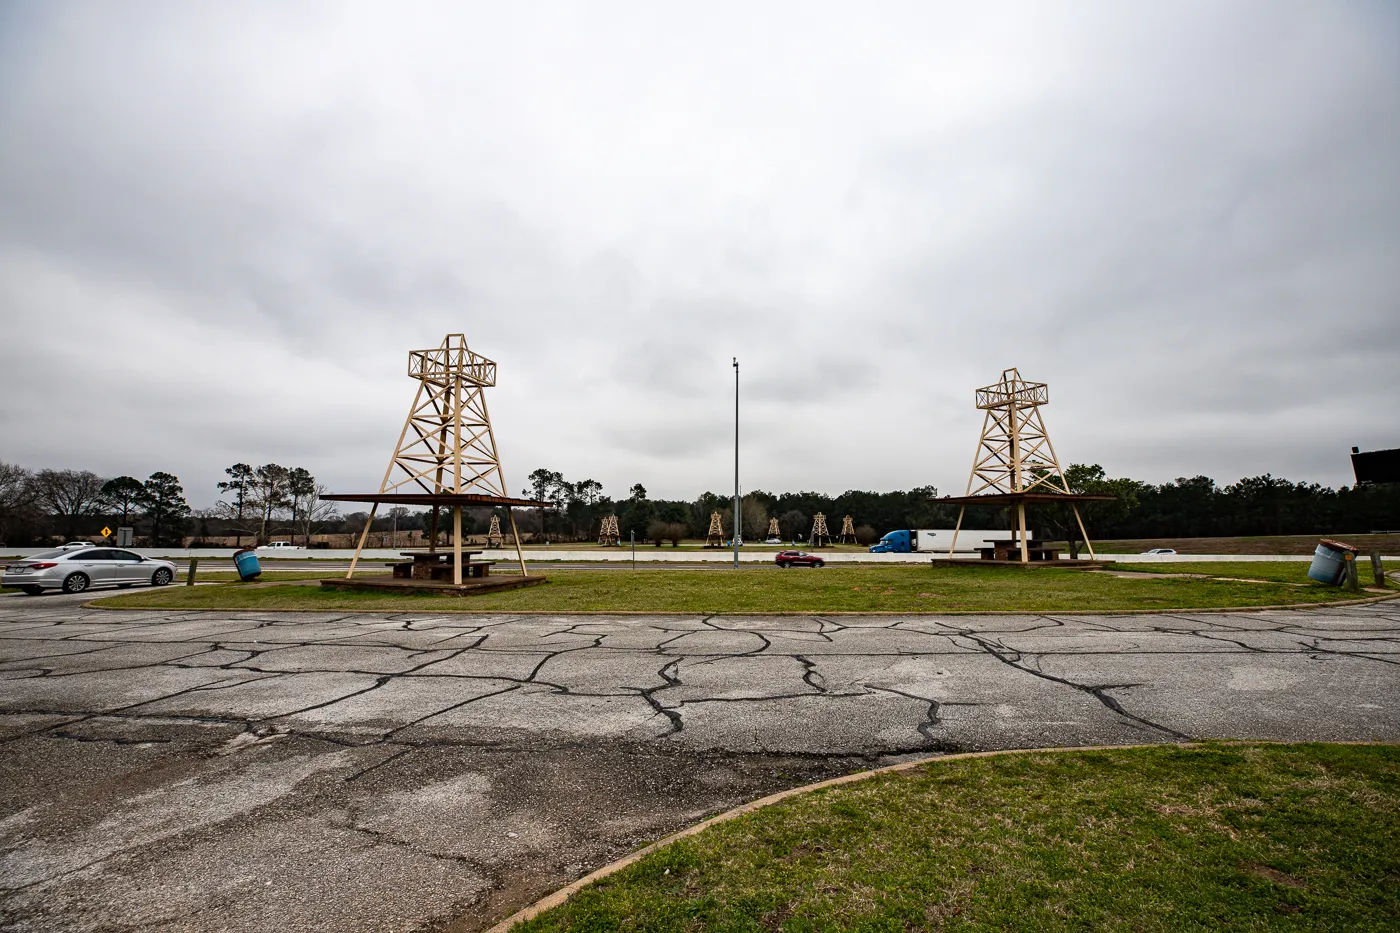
[322,333,550,586]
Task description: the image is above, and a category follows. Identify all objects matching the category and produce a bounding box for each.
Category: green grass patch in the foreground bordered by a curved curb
[515,744,1400,933]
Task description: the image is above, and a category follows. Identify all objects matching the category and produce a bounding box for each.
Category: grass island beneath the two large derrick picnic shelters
[90,565,1388,614]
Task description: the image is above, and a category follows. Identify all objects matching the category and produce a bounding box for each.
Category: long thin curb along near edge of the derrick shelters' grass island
[81,580,1400,618]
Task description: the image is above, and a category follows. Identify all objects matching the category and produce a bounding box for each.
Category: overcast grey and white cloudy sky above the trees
[0,0,1400,507]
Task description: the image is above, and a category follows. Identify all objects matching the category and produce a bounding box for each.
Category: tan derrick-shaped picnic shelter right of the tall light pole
[935,368,1113,563]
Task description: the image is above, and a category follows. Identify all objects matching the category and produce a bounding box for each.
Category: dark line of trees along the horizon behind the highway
[0,461,1400,549]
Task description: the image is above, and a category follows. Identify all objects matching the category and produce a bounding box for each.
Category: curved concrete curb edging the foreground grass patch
[486,740,1397,933]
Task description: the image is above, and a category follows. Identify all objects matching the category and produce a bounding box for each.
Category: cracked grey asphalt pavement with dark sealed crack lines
[0,597,1400,933]
